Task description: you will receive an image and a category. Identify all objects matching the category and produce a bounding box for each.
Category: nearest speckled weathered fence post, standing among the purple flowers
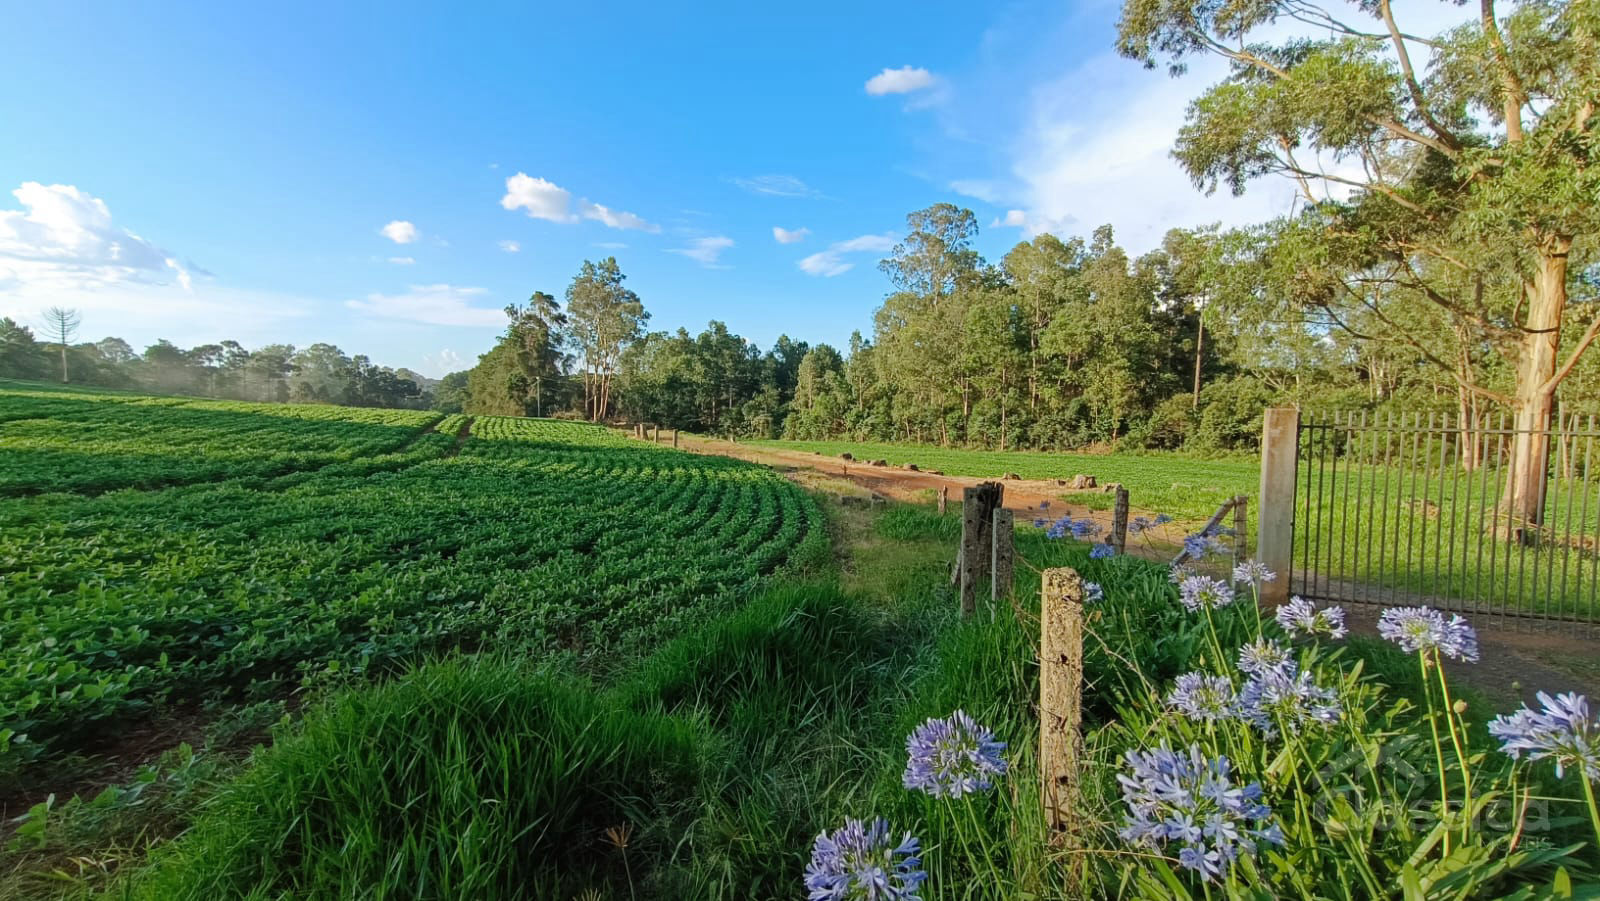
[1038,567,1083,843]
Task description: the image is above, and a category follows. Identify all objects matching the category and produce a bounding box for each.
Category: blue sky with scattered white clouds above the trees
[0,0,1312,376]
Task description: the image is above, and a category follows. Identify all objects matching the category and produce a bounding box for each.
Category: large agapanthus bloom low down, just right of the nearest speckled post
[1117,744,1283,880]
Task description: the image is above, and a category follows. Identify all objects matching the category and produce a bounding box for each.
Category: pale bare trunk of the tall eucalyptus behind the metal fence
[1501,238,1573,525]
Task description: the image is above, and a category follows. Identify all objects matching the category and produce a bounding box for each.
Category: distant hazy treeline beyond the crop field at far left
[0,318,438,410]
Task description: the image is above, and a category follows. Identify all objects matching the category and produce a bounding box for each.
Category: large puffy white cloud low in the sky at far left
[0,181,194,294]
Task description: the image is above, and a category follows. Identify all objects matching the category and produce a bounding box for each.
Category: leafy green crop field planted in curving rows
[0,382,826,773]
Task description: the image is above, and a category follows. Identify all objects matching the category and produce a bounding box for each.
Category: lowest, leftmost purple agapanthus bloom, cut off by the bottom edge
[805,818,928,901]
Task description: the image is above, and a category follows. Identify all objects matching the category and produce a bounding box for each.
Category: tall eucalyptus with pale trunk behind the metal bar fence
[1117,0,1600,522]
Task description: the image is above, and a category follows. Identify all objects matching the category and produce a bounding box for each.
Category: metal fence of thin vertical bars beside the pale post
[1290,413,1600,631]
